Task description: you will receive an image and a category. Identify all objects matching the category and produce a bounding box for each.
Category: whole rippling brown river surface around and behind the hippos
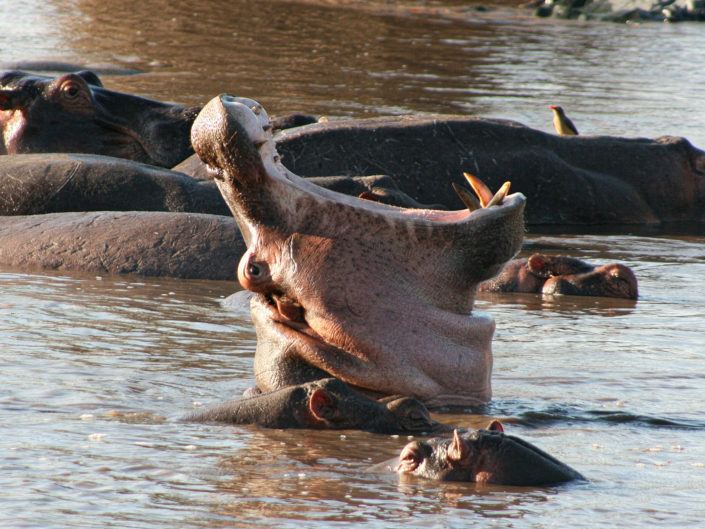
[0,0,705,529]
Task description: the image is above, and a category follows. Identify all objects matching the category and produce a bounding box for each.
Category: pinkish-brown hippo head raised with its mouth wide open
[191,95,525,406]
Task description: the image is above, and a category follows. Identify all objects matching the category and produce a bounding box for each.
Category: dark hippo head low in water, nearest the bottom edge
[395,421,585,487]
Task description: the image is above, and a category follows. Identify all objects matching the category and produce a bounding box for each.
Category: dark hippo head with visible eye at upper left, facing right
[0,71,198,167]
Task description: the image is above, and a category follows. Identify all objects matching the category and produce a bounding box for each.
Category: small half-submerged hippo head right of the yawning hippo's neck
[478,254,638,299]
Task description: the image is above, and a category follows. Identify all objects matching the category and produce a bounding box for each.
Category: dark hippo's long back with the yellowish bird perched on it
[276,115,705,225]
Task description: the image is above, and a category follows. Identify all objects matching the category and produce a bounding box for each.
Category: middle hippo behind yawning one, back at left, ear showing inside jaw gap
[0,153,438,215]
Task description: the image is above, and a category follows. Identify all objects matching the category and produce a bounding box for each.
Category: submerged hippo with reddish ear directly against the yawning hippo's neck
[182,378,446,434]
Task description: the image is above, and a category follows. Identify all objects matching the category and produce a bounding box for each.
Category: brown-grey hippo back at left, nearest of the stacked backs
[0,211,245,281]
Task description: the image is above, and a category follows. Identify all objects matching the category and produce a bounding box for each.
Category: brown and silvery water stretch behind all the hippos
[0,0,705,147]
